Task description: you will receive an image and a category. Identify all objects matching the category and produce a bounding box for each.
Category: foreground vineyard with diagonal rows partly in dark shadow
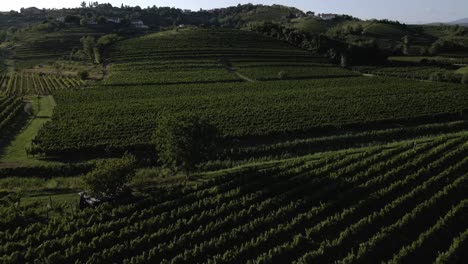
[0,132,468,263]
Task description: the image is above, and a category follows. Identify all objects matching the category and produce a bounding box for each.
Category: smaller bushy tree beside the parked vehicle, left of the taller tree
[83,154,136,198]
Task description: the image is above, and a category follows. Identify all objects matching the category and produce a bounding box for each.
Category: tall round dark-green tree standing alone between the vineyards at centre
[153,116,218,178]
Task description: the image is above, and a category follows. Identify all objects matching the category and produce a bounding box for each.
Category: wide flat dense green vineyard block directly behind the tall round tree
[31,77,468,155]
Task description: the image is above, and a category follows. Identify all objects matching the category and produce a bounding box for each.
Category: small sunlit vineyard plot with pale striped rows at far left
[0,73,83,95]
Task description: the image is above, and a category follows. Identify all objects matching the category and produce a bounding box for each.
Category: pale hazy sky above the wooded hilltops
[0,0,468,23]
